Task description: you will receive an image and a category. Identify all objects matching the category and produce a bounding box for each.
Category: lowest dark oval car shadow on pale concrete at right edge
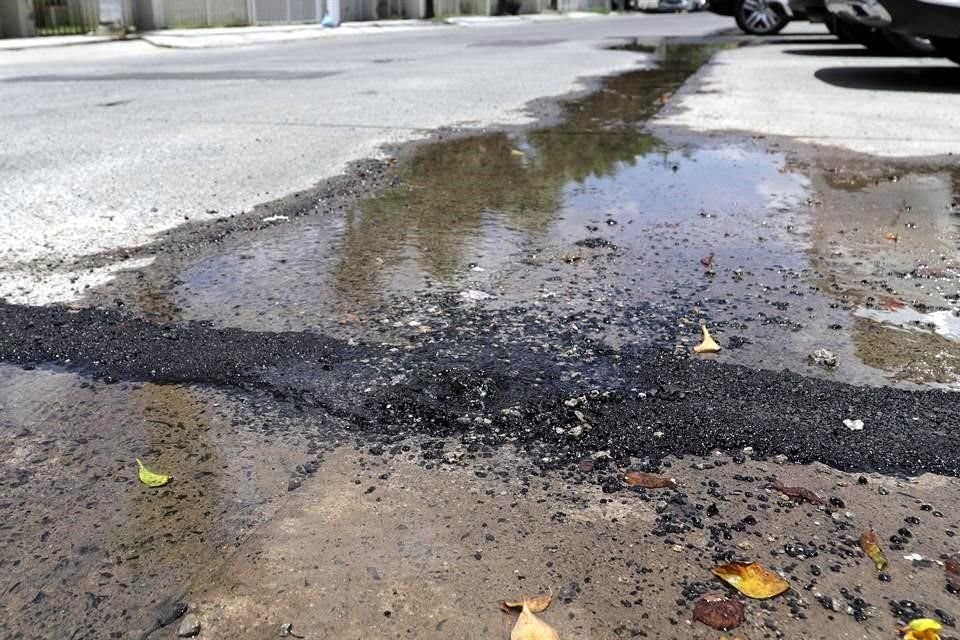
[813,63,960,93]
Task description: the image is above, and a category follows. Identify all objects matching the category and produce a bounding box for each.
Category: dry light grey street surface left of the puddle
[0,13,729,303]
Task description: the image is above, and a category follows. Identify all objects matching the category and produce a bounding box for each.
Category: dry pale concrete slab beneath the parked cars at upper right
[657,41,960,157]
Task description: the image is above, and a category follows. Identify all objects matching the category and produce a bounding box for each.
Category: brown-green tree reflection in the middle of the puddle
[334,127,656,303]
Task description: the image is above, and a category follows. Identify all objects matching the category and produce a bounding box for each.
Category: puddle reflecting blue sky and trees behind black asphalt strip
[165,47,805,338]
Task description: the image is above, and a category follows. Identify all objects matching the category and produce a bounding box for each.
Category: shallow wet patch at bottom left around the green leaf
[0,367,312,638]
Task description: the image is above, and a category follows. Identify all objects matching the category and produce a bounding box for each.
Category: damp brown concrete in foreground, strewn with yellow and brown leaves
[189,449,957,640]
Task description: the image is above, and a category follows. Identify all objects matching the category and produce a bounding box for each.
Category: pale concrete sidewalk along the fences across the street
[0,11,636,51]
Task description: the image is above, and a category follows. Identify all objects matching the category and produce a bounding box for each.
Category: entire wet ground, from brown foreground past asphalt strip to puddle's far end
[0,32,960,638]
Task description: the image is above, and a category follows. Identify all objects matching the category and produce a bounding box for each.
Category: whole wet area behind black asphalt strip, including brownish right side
[95,46,960,384]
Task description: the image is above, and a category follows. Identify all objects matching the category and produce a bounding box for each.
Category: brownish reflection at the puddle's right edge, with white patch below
[810,168,960,384]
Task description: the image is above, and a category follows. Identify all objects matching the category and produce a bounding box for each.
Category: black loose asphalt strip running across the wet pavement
[0,304,960,480]
